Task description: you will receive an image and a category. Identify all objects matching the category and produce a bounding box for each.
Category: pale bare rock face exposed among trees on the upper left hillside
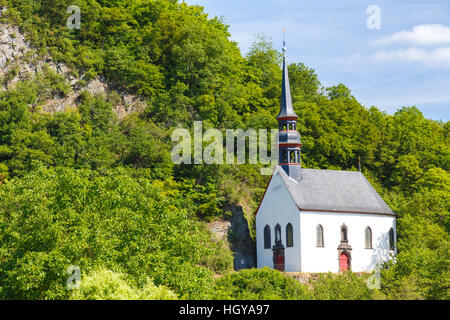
[0,16,146,119]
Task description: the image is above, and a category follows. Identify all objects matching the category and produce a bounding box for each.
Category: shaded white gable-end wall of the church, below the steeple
[256,171,301,272]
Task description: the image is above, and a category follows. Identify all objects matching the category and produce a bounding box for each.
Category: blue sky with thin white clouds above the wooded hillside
[186,0,450,121]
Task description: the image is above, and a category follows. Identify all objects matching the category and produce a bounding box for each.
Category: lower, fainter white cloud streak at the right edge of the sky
[372,47,450,67]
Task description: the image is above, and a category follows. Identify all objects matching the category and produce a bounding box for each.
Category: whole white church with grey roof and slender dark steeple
[255,42,396,272]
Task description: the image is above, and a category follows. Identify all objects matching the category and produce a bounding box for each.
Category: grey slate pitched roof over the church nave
[274,166,395,215]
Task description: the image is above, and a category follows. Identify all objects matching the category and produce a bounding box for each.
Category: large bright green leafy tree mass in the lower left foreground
[0,168,220,299]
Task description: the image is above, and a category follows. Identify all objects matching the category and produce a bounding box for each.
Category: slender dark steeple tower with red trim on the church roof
[277,41,302,181]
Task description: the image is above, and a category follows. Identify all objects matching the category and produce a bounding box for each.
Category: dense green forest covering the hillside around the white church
[0,0,450,299]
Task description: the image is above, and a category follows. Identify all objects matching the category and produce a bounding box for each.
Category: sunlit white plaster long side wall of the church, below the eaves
[300,212,397,272]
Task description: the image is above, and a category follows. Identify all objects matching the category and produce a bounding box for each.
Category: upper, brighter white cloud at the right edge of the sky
[372,24,450,45]
